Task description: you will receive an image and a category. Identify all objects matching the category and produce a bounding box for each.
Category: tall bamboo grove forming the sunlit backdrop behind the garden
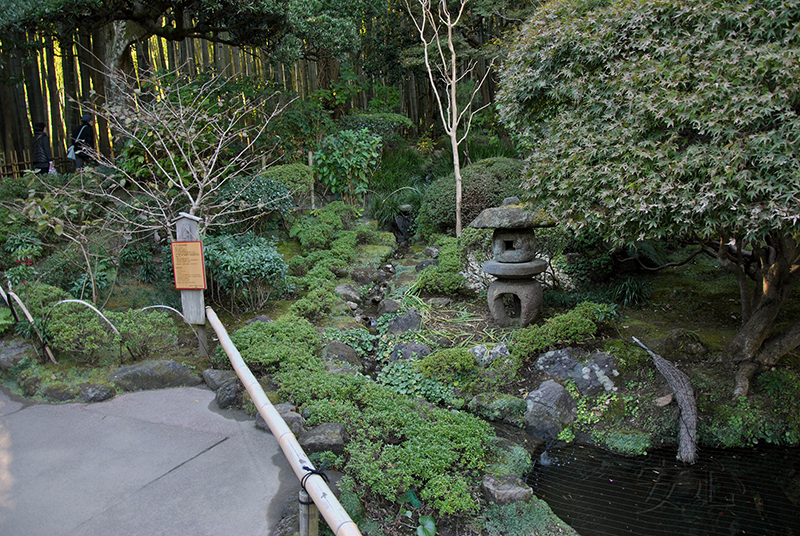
[0,0,534,176]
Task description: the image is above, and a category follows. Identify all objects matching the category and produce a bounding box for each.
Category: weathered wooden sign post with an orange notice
[172,212,208,357]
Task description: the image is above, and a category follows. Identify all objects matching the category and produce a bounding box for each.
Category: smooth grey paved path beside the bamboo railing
[0,387,299,536]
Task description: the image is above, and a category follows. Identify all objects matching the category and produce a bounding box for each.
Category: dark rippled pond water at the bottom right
[528,447,800,536]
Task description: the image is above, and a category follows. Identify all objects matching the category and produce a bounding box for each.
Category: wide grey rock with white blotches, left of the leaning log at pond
[536,348,619,396]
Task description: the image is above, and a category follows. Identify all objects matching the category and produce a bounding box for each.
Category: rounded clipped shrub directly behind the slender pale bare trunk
[417,158,523,236]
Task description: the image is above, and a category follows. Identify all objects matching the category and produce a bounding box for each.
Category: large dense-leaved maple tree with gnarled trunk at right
[499,0,800,394]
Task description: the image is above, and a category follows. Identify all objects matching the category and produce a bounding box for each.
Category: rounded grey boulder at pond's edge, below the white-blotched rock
[524,380,578,439]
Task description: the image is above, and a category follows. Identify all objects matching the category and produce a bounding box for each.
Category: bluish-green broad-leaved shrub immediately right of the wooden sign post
[204,233,288,311]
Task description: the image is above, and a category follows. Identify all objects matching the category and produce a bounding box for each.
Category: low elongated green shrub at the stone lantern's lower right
[513,302,613,356]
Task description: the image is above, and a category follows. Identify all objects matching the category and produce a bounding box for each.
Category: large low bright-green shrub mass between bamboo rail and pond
[275,348,492,515]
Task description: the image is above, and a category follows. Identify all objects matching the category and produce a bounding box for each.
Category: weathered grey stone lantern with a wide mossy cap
[470,197,553,327]
